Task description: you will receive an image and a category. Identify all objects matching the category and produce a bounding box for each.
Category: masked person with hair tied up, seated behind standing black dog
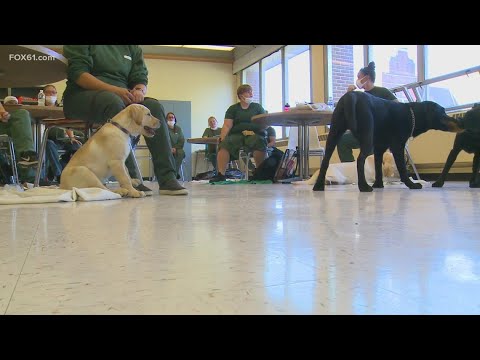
[337,61,398,162]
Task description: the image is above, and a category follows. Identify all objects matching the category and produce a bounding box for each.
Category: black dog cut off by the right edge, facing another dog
[432,104,480,188]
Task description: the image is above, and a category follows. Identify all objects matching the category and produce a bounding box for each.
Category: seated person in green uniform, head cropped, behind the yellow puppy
[63,45,188,195]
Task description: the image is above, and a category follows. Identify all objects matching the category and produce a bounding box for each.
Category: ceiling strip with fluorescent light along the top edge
[43,45,258,62]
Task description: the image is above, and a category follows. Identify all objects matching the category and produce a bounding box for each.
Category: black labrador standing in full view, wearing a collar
[313,91,461,192]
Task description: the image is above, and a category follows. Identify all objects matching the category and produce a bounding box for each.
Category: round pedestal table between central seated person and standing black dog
[252,110,333,179]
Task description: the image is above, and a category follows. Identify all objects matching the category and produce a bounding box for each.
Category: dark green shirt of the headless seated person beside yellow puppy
[63,45,148,92]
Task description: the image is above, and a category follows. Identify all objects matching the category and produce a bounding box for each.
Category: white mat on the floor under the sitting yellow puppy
[0,187,122,205]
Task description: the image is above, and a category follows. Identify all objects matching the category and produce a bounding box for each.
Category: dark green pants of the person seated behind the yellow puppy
[63,90,176,185]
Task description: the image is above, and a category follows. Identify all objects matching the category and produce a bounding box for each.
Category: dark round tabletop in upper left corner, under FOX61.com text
[0,45,67,88]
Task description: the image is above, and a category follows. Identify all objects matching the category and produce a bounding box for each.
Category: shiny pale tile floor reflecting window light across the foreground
[0,182,480,314]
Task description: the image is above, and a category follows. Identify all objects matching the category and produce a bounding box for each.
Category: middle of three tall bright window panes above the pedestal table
[262,50,283,138]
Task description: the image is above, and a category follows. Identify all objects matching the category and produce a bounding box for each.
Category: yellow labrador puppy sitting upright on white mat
[60,104,160,197]
